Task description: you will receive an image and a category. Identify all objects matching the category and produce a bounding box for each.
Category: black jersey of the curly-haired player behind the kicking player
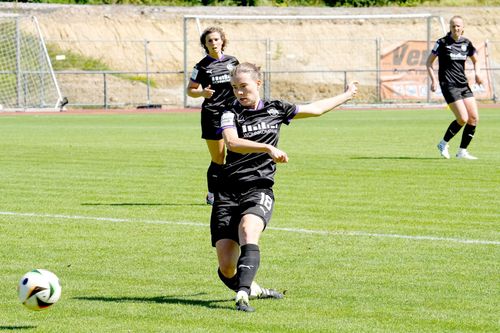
[191,55,239,111]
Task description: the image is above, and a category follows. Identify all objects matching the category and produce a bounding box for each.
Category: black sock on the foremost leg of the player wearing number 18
[237,244,260,294]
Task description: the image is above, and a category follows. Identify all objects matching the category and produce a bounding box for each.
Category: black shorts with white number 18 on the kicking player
[210,188,274,246]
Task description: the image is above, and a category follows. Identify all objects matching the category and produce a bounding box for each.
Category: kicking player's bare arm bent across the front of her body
[222,128,288,163]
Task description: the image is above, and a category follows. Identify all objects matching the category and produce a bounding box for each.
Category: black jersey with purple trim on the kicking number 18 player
[221,100,298,189]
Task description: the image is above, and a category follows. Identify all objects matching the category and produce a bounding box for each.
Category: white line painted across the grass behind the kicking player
[0,211,500,245]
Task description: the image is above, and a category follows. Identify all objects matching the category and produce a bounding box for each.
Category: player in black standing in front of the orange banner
[427,16,483,160]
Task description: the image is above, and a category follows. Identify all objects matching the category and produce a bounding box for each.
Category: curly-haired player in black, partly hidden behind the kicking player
[187,27,239,204]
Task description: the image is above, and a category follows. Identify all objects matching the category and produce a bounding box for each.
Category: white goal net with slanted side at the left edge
[0,14,62,111]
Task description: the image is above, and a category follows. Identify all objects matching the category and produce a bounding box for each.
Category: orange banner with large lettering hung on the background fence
[380,41,493,101]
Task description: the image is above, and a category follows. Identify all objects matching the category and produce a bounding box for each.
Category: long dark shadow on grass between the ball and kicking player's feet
[73,293,234,309]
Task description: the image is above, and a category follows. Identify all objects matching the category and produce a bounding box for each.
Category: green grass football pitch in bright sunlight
[0,109,500,333]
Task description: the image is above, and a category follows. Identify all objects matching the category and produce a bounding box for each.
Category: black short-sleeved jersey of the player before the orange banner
[432,33,476,86]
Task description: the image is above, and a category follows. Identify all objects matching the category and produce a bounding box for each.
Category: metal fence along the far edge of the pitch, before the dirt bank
[48,38,500,108]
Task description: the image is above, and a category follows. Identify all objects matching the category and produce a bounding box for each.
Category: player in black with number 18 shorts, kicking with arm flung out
[210,63,357,312]
